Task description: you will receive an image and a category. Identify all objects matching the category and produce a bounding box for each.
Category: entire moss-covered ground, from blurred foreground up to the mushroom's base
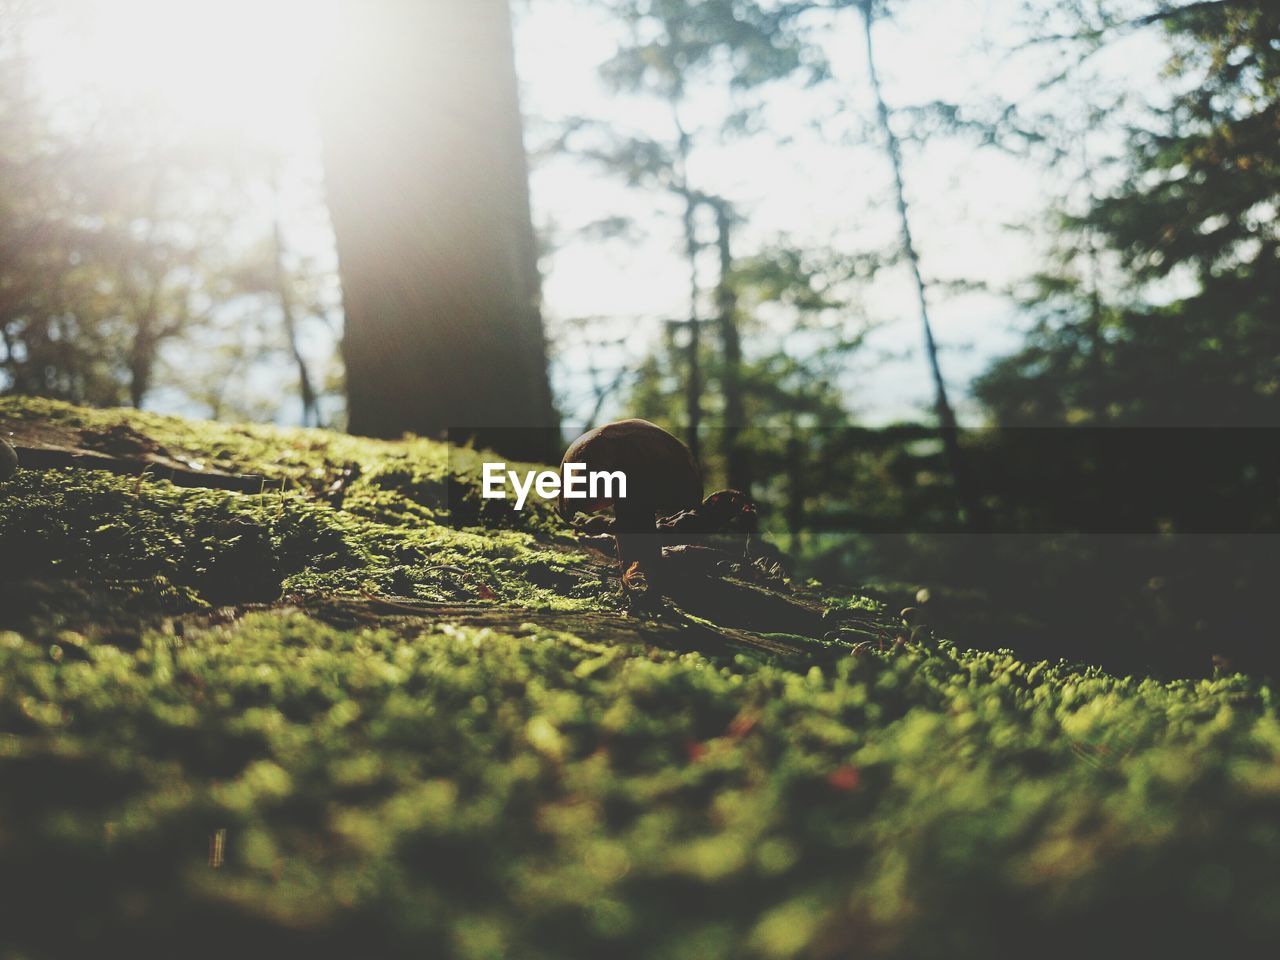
[0,399,1280,960]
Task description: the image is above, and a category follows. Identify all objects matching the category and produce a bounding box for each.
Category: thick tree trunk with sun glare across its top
[323,0,558,458]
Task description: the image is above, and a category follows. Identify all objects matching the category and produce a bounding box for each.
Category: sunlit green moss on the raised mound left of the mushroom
[0,399,618,626]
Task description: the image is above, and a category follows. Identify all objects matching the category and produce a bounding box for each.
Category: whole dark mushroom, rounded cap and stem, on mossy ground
[559,420,703,591]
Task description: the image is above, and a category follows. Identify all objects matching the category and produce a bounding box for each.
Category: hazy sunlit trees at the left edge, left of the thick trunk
[0,0,311,407]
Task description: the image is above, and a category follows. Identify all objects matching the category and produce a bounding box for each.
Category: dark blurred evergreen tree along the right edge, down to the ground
[878,0,1280,671]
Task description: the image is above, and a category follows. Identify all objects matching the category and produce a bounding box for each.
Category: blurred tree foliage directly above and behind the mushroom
[550,0,861,489]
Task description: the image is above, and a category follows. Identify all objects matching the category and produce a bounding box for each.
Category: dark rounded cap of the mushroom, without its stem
[559,420,703,517]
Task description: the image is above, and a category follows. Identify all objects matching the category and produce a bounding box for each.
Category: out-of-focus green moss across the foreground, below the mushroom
[0,613,1280,957]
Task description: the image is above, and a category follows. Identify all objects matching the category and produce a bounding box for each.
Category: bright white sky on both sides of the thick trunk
[17,0,1164,424]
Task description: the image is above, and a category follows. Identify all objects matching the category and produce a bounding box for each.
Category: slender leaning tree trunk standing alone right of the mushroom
[858,0,979,524]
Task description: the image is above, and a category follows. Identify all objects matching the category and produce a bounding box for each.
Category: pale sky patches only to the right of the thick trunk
[517,0,1164,424]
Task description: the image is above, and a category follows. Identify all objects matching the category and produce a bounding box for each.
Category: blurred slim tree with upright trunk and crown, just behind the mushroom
[556,0,819,490]
